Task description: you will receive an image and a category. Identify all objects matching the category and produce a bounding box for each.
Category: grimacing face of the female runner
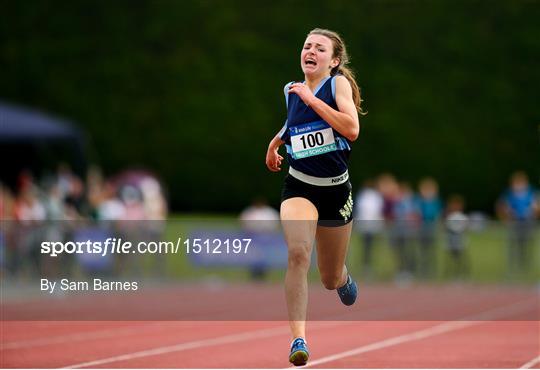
[300,35,339,76]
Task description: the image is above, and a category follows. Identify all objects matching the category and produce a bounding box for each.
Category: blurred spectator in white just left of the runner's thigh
[240,198,279,280]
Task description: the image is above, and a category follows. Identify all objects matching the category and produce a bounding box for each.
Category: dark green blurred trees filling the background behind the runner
[0,0,540,211]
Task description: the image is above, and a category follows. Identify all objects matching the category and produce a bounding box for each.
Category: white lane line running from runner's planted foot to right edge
[294,300,536,369]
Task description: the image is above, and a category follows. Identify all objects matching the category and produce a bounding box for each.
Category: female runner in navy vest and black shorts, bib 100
[266,28,362,366]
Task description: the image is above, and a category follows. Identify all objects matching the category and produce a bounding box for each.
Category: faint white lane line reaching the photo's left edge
[0,323,157,350]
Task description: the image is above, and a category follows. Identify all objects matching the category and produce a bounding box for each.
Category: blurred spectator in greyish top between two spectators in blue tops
[444,195,469,278]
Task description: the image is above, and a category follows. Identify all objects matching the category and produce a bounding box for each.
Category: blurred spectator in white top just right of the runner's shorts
[355,180,384,277]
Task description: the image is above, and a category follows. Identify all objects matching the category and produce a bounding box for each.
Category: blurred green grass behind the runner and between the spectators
[160,215,540,283]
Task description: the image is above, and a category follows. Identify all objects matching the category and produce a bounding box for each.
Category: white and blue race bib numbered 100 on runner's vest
[289,121,337,159]
